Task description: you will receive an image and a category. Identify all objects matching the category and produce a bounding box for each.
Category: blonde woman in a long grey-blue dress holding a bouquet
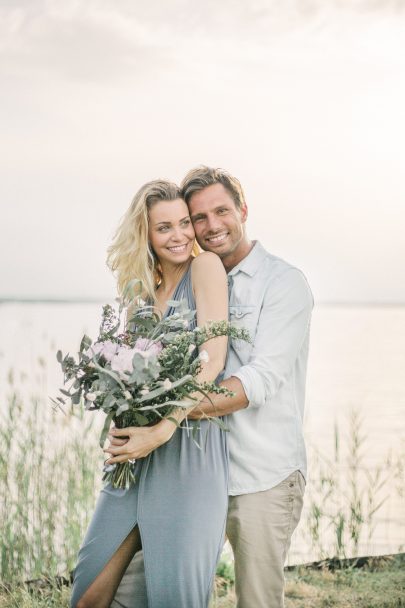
[71,181,228,608]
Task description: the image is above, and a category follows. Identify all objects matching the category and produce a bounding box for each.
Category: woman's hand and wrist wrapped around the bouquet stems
[104,420,176,464]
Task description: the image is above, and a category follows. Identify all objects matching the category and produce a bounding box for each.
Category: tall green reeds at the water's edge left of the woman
[0,366,101,582]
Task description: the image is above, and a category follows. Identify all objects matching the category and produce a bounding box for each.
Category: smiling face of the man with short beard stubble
[188,184,250,267]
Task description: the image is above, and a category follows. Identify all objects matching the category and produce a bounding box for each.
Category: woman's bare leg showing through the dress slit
[75,526,141,608]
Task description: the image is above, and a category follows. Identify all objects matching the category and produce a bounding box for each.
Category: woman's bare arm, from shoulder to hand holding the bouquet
[104,252,228,464]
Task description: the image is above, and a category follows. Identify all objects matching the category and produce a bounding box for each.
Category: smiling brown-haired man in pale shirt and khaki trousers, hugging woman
[112,166,313,608]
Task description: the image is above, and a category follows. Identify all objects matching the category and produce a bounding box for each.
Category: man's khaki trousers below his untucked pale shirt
[226,471,305,608]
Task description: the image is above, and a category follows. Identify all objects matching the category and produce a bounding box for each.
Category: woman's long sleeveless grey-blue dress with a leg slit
[71,268,228,608]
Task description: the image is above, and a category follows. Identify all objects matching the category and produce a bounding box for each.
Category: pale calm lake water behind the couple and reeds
[0,303,405,563]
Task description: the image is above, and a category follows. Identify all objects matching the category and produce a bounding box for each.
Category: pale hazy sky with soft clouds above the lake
[0,0,405,303]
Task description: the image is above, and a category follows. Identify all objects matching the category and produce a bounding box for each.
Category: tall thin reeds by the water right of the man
[301,409,404,559]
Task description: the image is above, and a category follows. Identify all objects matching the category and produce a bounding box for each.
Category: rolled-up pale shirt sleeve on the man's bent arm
[232,268,313,407]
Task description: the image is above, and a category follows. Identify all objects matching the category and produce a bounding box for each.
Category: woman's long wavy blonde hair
[107,180,198,301]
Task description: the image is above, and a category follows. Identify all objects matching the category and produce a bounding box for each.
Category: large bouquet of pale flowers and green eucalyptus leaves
[52,288,249,488]
